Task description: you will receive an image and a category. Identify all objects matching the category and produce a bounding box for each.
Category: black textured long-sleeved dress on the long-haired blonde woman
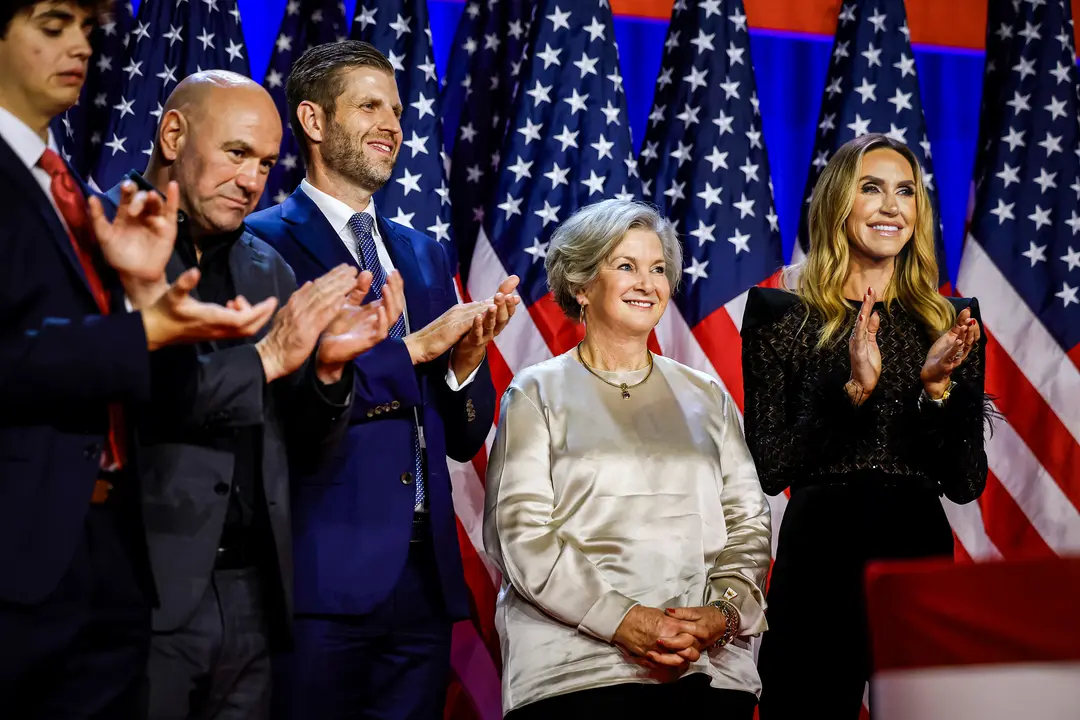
[742,288,987,720]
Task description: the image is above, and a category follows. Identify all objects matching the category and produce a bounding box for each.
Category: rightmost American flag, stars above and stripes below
[946,0,1080,559]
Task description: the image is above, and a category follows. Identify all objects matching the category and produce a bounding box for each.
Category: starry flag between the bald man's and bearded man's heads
[259,0,348,207]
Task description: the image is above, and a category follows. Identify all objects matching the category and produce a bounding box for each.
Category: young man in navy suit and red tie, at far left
[0,0,274,720]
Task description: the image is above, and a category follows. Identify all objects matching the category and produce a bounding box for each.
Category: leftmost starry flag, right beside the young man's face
[53,2,134,177]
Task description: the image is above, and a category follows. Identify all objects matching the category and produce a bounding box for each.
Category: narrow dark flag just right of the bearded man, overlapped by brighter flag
[442,0,536,720]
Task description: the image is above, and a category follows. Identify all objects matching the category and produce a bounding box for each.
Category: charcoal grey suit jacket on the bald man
[107,181,351,647]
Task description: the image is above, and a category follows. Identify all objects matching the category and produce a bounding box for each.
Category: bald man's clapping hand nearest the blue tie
[315,270,405,384]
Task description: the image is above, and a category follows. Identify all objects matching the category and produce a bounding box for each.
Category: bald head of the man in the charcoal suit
[146,70,282,235]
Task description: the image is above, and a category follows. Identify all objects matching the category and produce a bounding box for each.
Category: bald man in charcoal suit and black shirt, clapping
[103,70,403,720]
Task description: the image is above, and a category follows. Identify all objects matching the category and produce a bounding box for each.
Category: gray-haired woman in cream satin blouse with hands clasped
[484,200,770,720]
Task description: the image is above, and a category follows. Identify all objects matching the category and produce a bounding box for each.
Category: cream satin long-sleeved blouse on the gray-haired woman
[484,351,770,711]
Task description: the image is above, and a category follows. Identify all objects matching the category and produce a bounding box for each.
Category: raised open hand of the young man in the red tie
[89,180,180,308]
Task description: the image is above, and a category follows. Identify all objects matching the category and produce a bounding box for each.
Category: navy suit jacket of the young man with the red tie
[0,133,152,603]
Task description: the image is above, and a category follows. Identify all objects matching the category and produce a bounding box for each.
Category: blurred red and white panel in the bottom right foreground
[867,558,1080,720]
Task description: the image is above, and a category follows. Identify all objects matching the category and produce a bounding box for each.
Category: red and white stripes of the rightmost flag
[954,236,1080,559]
